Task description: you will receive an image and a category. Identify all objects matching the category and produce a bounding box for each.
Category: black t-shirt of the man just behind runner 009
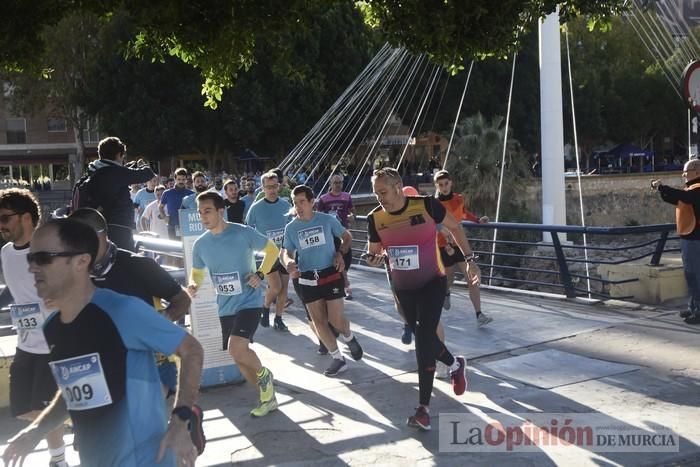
[93,249,182,306]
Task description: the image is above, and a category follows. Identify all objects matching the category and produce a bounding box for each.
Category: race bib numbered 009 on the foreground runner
[49,353,112,410]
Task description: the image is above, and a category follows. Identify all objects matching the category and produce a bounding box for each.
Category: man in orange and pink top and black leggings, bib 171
[366,168,470,430]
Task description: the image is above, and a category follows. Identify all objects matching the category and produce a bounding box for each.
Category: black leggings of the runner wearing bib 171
[396,276,455,405]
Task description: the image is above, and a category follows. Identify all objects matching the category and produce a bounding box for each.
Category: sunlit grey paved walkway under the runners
[0,270,700,466]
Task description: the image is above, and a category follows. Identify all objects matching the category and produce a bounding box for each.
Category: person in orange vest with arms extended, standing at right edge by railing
[651,159,700,324]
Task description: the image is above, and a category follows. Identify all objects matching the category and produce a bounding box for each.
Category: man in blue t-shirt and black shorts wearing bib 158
[280,185,362,376]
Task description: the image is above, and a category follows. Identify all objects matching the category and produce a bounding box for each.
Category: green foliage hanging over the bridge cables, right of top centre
[357,0,624,70]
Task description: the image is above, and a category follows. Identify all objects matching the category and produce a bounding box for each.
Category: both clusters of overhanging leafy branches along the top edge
[0,0,623,107]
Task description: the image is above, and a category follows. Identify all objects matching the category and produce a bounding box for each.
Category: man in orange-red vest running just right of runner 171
[434,170,493,327]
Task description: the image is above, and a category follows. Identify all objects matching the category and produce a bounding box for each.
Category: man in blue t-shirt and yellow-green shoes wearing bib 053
[188,192,279,417]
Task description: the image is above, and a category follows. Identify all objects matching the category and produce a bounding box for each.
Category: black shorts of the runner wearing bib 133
[10,349,58,417]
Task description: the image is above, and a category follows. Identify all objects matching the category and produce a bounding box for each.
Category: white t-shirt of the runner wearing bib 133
[0,243,51,354]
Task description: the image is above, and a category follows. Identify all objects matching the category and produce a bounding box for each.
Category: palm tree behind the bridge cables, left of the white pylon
[447,113,529,215]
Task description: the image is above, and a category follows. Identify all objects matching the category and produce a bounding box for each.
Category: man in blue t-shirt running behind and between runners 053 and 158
[245,172,292,331]
